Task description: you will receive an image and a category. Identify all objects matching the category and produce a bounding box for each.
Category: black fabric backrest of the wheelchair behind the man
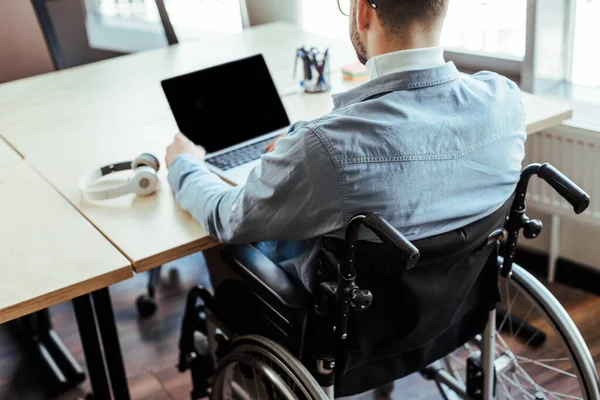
[324,199,512,396]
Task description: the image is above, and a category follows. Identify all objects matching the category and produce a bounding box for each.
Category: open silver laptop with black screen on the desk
[161,55,290,184]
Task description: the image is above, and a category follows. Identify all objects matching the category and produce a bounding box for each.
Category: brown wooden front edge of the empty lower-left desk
[0,265,133,324]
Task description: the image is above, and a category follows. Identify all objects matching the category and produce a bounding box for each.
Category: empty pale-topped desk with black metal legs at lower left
[0,138,133,399]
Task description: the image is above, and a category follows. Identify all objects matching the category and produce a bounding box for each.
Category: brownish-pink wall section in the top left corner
[0,0,54,83]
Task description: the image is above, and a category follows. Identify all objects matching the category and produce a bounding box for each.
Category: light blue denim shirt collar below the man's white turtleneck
[333,62,460,110]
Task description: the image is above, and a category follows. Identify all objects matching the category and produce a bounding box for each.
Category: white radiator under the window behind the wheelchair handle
[523,126,600,281]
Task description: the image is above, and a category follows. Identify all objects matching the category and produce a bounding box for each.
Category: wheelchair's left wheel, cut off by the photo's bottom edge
[211,336,327,400]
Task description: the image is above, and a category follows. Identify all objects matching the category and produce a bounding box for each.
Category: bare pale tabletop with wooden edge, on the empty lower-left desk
[0,139,133,323]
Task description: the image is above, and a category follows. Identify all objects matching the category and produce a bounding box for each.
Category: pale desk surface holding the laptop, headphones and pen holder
[0,23,570,272]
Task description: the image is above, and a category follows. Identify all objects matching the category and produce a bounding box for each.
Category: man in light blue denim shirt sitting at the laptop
[167,0,526,289]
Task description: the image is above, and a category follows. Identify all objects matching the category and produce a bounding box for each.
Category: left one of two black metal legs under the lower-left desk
[73,294,112,400]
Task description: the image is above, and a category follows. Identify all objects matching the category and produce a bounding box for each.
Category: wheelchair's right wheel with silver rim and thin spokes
[444,265,600,400]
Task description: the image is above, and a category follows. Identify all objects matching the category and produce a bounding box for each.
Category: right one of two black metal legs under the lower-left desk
[92,288,131,400]
